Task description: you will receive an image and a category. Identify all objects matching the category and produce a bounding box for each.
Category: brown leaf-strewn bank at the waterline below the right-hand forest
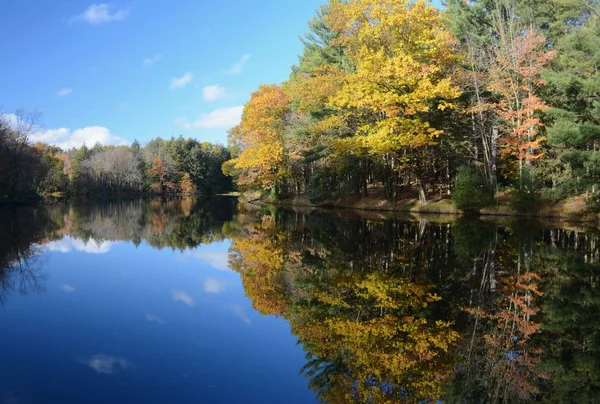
[240,192,600,225]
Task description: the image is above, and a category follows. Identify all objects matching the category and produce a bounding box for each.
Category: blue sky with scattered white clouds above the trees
[0,0,324,147]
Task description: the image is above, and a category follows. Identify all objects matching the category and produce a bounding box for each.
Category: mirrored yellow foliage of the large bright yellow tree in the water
[289,271,458,403]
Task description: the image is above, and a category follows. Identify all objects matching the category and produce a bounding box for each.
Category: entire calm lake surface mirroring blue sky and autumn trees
[0,198,600,404]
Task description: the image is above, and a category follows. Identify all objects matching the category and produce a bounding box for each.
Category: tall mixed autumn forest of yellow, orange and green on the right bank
[224,0,600,215]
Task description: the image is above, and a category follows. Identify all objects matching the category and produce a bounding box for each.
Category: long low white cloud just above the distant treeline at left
[29,126,129,150]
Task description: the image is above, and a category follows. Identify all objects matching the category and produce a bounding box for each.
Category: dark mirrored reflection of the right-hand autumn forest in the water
[226,209,600,403]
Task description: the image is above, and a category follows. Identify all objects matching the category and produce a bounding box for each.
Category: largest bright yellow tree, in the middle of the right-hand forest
[327,0,460,201]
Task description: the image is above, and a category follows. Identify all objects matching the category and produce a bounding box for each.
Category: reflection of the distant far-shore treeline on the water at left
[0,198,235,303]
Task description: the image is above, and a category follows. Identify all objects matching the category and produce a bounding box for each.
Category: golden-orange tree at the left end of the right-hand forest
[224,85,290,190]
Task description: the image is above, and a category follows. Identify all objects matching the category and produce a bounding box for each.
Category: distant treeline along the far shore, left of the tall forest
[0,114,232,199]
